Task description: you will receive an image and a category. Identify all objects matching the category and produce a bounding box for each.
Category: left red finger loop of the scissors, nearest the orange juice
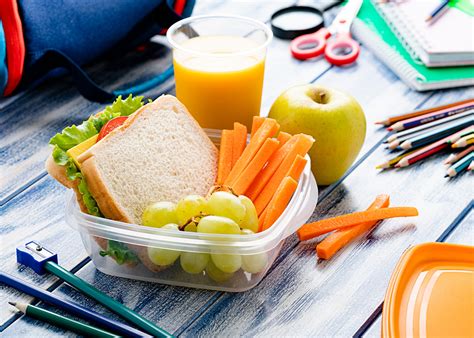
[290,27,331,60]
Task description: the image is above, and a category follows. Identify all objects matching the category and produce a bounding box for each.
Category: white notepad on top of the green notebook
[374,0,474,67]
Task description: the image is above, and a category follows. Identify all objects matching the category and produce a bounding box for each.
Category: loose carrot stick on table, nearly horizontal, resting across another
[298,207,418,241]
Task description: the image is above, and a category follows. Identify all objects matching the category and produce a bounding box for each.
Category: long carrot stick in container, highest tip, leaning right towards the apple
[224,119,280,186]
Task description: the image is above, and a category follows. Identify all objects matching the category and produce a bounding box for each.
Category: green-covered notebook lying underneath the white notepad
[351,1,474,91]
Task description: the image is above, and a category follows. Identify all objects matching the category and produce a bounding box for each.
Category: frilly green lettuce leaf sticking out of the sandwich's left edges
[49,94,144,217]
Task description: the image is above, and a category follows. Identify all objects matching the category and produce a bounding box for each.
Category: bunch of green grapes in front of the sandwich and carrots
[142,191,268,282]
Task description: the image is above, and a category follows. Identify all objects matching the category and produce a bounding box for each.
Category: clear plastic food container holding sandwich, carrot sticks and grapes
[66,130,318,292]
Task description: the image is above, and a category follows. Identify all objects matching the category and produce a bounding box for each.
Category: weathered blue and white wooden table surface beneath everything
[0,0,474,337]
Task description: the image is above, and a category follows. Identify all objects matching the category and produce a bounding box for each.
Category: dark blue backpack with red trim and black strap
[0,0,195,102]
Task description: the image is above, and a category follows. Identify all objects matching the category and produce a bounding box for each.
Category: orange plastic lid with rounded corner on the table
[382,243,474,337]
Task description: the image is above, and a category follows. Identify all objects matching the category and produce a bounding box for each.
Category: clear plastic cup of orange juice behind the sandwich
[167,15,272,129]
